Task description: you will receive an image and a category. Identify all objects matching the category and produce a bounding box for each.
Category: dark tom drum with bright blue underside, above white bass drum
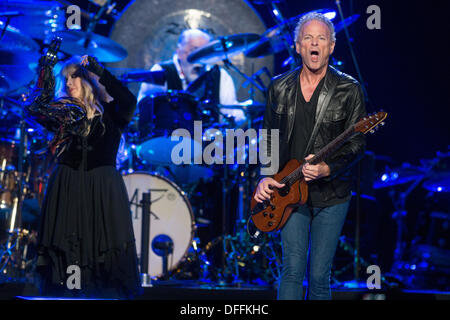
[136,91,214,185]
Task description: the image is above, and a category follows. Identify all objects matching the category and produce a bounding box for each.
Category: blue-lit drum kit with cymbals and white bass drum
[0,1,370,283]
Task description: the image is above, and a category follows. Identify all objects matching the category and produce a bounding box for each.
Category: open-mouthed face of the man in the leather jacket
[295,20,335,72]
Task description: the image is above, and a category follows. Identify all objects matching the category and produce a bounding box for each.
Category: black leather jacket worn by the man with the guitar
[263,66,366,202]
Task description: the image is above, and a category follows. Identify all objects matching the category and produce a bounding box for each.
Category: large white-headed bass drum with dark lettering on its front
[123,172,195,277]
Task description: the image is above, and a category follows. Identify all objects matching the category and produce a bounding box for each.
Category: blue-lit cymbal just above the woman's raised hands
[54,30,128,62]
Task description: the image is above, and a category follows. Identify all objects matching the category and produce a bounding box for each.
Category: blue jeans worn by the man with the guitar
[278,201,350,300]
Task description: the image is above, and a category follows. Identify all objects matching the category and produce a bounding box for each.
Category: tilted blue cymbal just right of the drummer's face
[187,33,261,64]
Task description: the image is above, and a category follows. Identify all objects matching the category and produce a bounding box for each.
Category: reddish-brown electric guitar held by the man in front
[250,112,387,232]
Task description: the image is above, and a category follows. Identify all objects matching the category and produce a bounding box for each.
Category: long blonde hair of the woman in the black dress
[56,56,107,119]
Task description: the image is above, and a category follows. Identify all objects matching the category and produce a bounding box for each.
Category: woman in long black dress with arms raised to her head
[27,46,141,298]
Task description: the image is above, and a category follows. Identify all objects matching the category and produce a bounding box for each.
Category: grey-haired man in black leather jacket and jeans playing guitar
[254,13,366,299]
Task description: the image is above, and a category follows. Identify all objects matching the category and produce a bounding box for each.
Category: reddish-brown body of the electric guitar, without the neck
[250,159,308,232]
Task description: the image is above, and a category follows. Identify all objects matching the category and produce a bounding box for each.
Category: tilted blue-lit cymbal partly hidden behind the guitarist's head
[245,9,359,58]
